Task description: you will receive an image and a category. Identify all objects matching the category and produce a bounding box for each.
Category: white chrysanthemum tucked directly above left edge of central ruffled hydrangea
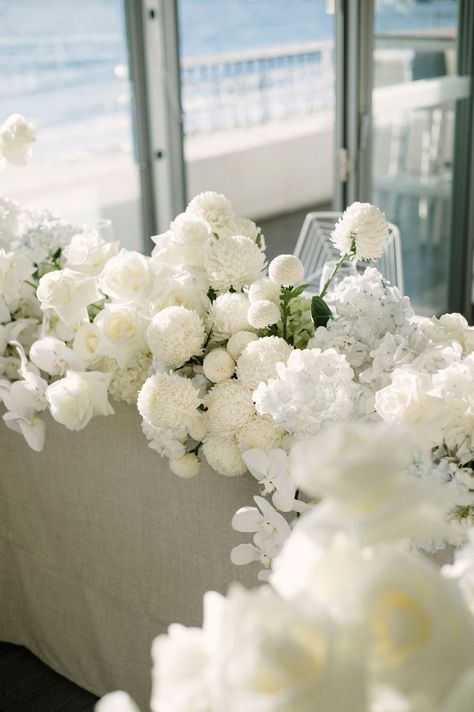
[237,336,293,391]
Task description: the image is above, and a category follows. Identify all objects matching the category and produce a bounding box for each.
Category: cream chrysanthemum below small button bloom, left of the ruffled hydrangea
[206,379,255,434]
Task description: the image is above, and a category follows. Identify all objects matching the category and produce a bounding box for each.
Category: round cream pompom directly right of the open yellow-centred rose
[146,306,206,368]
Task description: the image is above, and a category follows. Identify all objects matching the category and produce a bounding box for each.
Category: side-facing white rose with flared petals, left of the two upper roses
[36,269,103,326]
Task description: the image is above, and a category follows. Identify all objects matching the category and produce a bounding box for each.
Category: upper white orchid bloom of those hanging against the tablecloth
[242,448,296,512]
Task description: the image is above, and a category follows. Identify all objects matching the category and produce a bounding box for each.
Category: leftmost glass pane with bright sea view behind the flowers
[0,0,142,248]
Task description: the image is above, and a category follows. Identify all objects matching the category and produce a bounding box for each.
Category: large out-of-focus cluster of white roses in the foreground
[96,423,474,712]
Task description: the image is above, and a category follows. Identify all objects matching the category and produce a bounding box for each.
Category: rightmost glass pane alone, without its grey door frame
[372,0,457,314]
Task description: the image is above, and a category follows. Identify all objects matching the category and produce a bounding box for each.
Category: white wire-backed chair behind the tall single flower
[294,212,403,294]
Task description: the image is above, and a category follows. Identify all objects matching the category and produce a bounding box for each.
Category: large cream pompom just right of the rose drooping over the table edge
[137,373,201,428]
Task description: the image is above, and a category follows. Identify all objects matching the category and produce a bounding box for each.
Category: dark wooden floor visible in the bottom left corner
[0,643,97,712]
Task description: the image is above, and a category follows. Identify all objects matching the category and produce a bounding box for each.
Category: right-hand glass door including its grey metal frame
[339,0,473,314]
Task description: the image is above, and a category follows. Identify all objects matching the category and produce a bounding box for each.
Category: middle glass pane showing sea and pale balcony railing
[179,0,334,256]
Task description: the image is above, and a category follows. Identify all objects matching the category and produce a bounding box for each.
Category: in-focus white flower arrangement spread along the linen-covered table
[0,116,474,580]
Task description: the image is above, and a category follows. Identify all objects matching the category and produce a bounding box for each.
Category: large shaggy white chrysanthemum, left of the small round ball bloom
[204,235,265,292]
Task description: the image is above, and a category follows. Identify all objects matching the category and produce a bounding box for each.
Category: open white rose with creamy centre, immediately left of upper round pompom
[94,304,145,368]
